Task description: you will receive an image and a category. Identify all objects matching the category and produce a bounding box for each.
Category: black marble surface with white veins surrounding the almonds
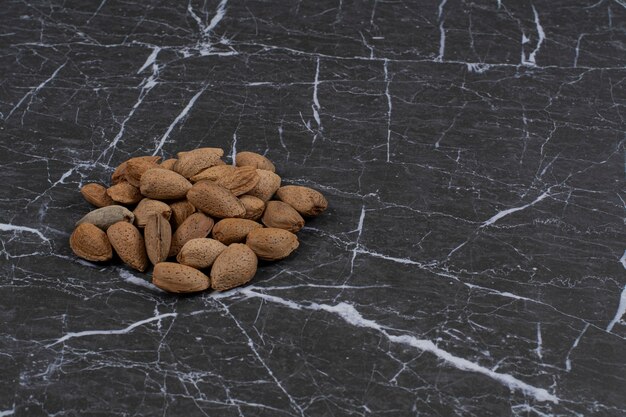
[0,0,626,417]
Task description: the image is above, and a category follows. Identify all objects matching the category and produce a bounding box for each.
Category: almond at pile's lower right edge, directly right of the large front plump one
[246,227,300,261]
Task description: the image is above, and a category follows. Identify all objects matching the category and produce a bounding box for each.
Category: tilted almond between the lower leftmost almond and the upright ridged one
[107,222,148,272]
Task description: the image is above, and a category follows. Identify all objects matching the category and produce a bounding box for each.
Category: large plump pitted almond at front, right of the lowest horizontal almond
[211,242,261,291]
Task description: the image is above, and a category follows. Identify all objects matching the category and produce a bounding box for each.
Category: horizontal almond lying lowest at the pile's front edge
[152,262,210,293]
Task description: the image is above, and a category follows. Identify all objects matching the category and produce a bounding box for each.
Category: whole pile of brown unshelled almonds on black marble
[70,148,328,293]
